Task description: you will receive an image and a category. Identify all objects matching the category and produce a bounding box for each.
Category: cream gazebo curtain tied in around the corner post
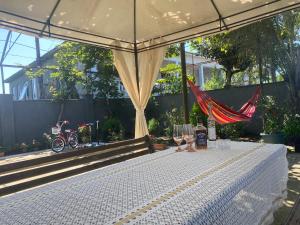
[113,41,166,138]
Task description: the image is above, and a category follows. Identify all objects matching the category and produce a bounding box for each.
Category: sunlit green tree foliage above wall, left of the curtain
[26,42,121,99]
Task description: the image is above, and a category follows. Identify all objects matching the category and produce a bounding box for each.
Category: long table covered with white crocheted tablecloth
[0,142,288,225]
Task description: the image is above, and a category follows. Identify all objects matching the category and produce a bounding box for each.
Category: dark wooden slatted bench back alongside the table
[0,136,153,196]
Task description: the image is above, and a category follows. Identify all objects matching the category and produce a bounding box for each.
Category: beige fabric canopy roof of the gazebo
[0,0,300,52]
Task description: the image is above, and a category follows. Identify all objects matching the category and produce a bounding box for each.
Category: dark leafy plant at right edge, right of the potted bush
[283,114,300,153]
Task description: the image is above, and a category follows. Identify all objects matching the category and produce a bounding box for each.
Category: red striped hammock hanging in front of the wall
[188,81,261,124]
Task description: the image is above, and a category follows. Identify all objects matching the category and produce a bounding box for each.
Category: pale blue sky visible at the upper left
[0,29,62,93]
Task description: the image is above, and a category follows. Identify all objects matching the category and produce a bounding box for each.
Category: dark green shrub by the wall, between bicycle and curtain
[101,117,124,142]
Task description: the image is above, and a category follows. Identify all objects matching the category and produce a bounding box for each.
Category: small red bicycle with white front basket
[51,120,78,153]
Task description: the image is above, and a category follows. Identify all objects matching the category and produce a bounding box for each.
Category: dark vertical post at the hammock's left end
[180,42,189,124]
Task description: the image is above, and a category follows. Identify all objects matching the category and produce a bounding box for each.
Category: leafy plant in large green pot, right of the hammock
[260,96,285,144]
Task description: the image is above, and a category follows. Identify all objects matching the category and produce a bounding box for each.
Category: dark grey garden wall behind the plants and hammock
[0,82,288,146]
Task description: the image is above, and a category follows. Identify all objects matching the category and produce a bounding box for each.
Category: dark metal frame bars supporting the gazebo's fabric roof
[0,0,300,53]
